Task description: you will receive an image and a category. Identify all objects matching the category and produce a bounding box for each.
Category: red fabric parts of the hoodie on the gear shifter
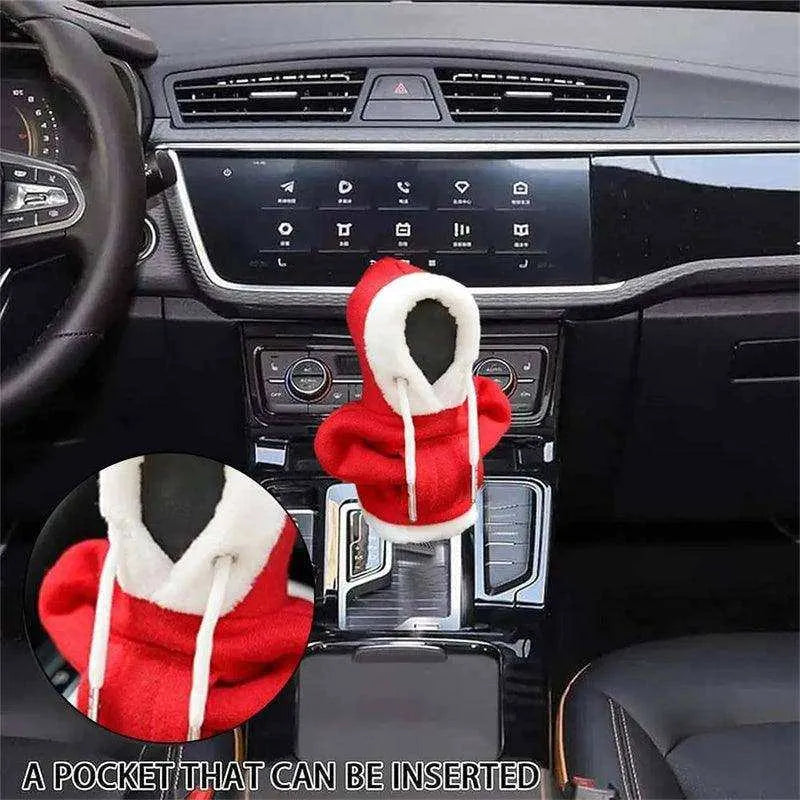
[314,258,511,525]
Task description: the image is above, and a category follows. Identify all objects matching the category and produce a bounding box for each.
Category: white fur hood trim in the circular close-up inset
[98,457,286,615]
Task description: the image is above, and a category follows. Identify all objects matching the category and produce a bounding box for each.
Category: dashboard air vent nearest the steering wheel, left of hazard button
[174,69,366,125]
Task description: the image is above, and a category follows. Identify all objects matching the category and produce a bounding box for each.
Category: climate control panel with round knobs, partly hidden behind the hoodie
[252,343,551,424]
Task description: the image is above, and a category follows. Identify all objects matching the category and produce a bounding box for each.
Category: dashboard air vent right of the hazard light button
[436,69,629,125]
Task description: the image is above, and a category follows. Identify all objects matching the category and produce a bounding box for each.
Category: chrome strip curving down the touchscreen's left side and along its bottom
[167,150,624,296]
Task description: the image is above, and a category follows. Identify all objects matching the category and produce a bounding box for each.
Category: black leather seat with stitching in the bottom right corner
[554,633,800,800]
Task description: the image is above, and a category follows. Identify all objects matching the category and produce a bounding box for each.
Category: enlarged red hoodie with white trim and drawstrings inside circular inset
[39,459,313,742]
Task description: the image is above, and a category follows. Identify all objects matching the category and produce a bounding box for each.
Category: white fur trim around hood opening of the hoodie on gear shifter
[364,272,481,415]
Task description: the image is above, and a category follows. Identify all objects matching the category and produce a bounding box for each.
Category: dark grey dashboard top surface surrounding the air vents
[115,2,800,142]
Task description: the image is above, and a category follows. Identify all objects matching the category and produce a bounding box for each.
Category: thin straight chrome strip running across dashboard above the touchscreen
[155,141,800,155]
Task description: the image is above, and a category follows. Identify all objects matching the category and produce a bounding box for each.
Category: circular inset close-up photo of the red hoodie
[26,453,314,742]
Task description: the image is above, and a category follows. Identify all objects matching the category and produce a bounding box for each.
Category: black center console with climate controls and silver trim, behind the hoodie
[247,321,561,763]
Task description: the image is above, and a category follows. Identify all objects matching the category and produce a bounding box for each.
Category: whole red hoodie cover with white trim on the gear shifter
[314,258,511,542]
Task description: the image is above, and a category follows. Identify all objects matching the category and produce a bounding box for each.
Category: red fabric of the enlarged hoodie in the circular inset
[39,519,313,742]
